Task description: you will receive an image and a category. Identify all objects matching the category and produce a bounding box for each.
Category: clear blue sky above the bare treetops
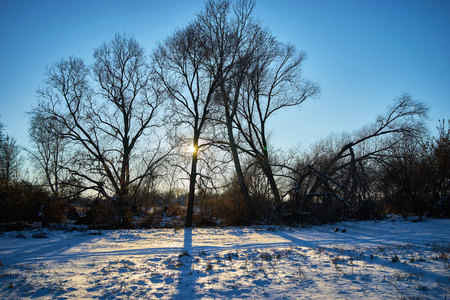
[0,0,450,152]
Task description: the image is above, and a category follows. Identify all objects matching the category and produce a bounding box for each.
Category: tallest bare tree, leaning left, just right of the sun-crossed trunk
[199,0,264,217]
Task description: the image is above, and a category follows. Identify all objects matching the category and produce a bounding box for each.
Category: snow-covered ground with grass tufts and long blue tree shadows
[0,218,450,299]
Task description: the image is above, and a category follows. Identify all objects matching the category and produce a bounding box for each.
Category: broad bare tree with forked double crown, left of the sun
[38,34,163,226]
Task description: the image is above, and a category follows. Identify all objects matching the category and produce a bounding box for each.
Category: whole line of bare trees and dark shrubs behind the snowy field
[0,0,450,228]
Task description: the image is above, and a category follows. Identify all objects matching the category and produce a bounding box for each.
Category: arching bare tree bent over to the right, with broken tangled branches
[292,94,427,221]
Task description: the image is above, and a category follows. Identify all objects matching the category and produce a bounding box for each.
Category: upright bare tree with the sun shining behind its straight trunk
[154,20,219,227]
